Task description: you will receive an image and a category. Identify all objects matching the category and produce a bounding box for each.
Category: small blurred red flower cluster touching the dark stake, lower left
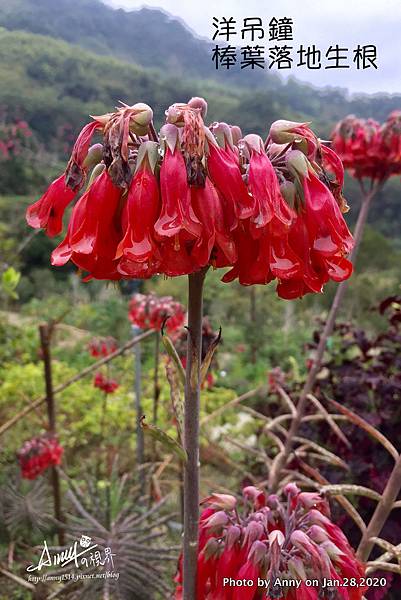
[17,435,64,479]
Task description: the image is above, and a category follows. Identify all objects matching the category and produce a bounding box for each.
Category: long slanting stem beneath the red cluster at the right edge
[269,183,381,492]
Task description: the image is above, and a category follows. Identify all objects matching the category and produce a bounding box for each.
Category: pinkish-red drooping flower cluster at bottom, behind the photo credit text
[176,484,367,600]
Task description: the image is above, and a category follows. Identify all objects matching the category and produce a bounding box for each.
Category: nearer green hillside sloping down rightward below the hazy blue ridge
[0,29,241,140]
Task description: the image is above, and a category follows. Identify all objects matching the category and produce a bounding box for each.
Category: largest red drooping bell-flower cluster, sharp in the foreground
[27,98,353,299]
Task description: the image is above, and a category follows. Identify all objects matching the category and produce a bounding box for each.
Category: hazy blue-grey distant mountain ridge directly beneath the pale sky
[0,0,401,126]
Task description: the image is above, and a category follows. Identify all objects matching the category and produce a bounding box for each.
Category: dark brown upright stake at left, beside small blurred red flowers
[39,323,64,546]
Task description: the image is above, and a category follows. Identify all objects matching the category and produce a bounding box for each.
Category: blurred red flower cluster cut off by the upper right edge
[332,111,401,181]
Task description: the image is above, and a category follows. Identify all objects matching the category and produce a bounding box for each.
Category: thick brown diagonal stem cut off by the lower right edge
[357,454,401,562]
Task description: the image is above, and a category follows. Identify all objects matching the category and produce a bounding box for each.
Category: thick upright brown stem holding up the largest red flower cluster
[183,268,207,600]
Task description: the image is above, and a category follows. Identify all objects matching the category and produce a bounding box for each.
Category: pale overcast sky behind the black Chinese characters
[104,0,401,93]
